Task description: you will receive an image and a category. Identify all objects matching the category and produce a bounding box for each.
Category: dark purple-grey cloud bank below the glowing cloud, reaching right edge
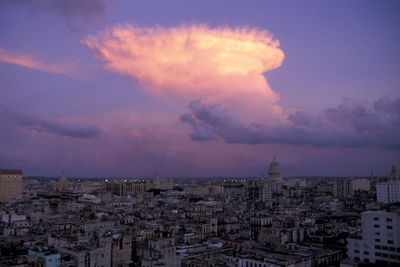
[181,97,400,149]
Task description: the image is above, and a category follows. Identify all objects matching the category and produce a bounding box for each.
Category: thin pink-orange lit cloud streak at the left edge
[0,48,72,75]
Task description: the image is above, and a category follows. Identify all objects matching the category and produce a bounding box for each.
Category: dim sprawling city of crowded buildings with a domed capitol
[0,162,400,267]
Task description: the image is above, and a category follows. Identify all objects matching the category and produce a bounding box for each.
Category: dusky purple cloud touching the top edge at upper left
[9,0,111,31]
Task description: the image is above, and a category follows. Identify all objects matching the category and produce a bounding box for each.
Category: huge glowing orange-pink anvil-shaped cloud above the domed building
[82,25,284,122]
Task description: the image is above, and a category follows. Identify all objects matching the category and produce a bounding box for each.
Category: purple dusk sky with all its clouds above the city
[0,0,400,177]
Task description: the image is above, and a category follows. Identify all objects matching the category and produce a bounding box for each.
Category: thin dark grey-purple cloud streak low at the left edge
[0,110,101,138]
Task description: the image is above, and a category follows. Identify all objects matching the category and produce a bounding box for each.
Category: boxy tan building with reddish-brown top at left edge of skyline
[0,169,22,202]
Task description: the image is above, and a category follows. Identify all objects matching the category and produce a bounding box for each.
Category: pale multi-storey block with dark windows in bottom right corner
[347,210,400,266]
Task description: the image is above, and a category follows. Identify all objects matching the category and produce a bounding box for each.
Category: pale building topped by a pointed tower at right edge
[376,166,400,204]
